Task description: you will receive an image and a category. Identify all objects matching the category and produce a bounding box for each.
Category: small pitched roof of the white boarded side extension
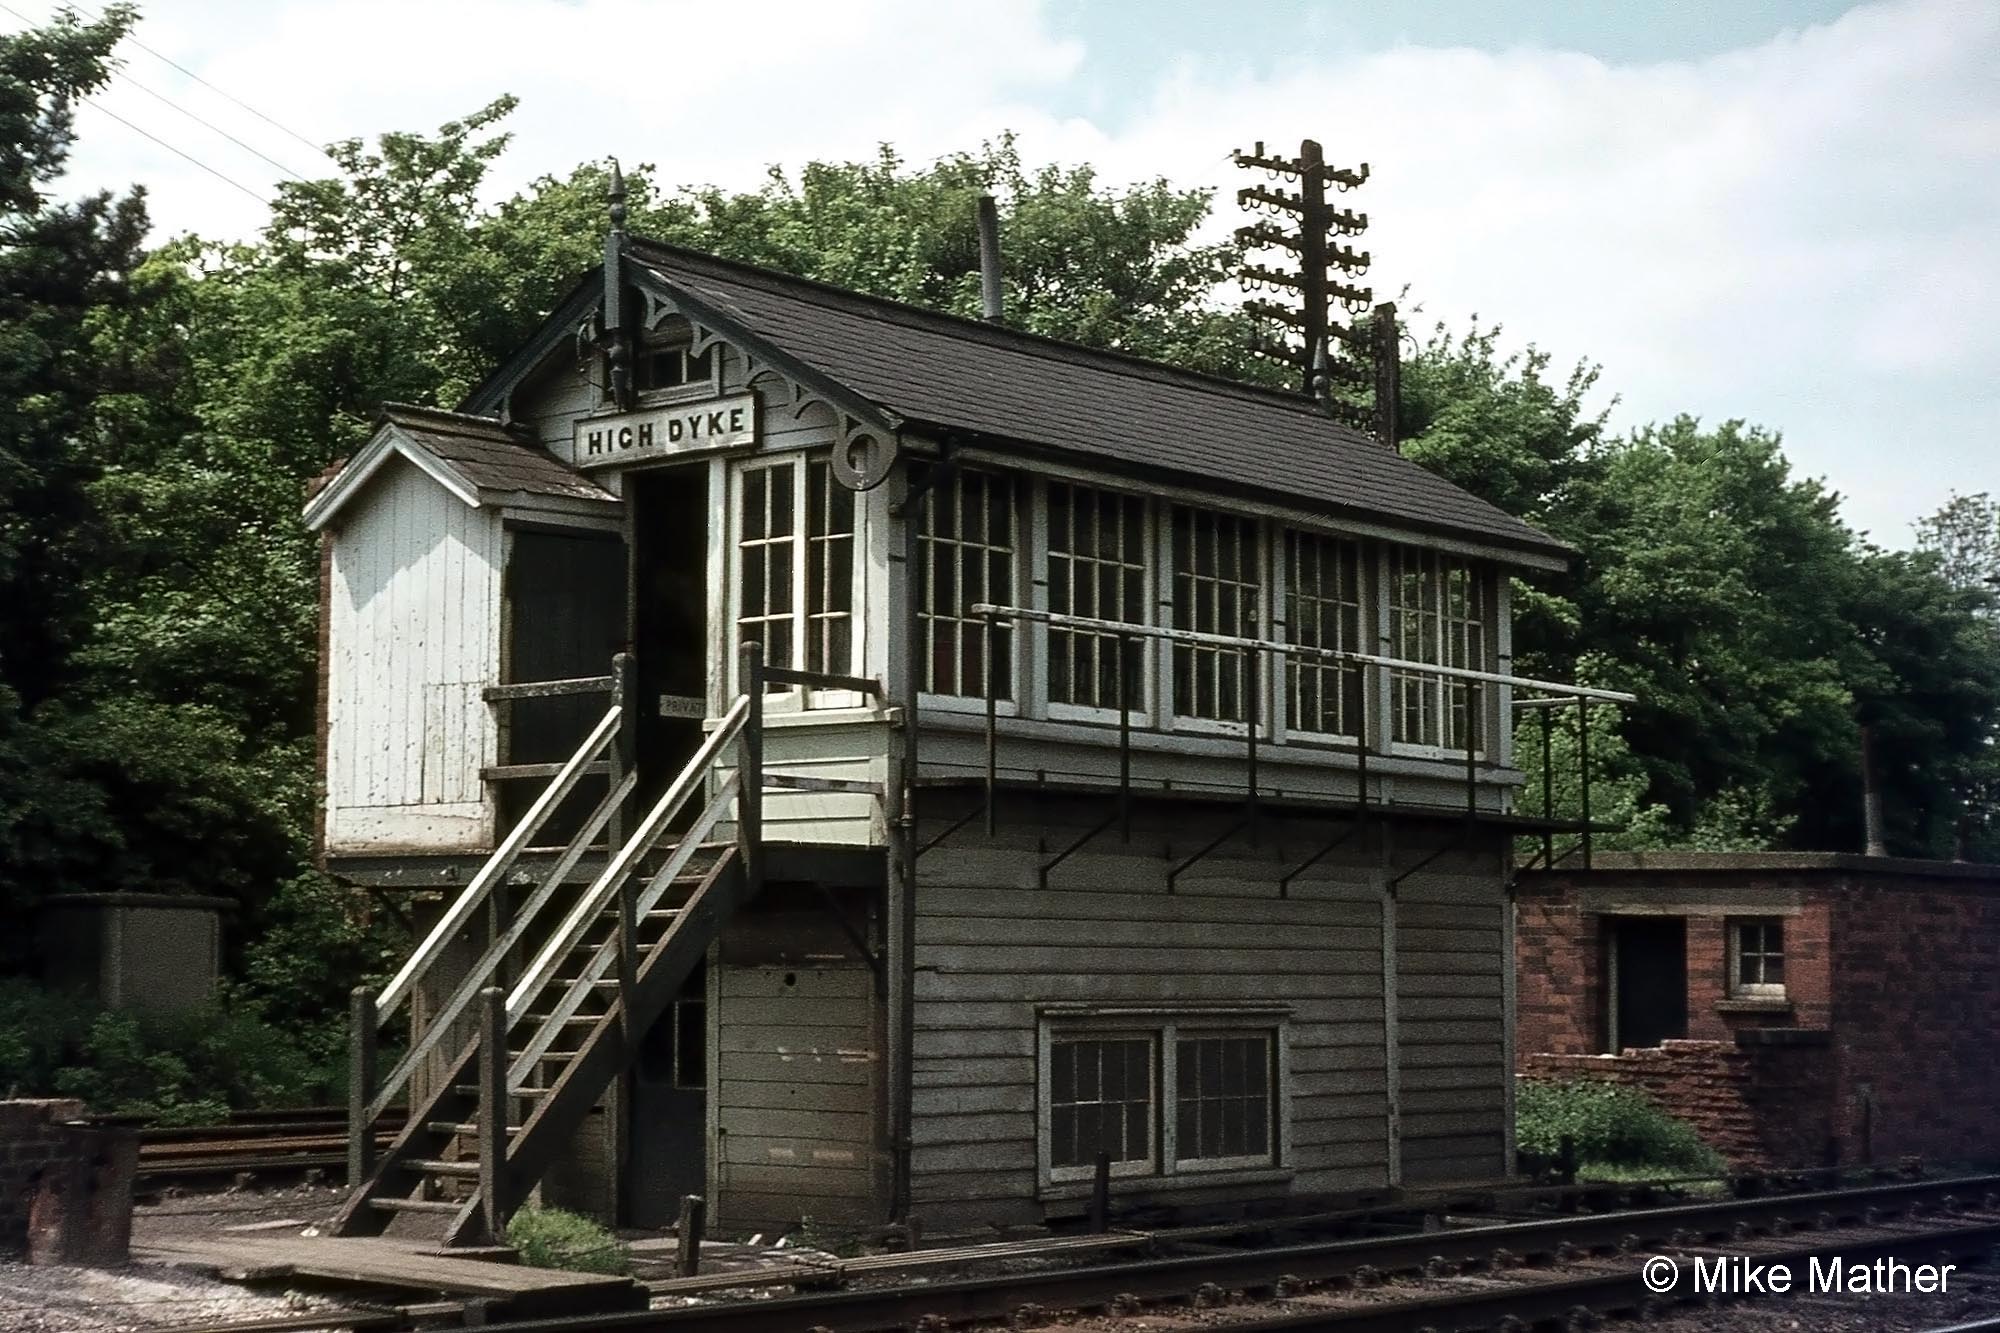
[306,402,618,528]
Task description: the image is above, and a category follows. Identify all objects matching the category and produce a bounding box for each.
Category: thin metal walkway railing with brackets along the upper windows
[968,602,1638,868]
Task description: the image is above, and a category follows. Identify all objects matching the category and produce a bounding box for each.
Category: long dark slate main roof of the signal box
[630,240,1570,558]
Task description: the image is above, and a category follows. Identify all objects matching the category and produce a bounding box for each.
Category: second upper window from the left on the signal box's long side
[1046,482,1146,709]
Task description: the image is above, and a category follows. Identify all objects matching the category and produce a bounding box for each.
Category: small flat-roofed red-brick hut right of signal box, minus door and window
[1516,853,2000,1165]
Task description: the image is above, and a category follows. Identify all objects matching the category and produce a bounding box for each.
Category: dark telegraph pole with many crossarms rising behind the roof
[1234,138,1398,448]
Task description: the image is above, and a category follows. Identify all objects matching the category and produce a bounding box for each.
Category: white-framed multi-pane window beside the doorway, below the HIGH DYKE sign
[736,460,854,675]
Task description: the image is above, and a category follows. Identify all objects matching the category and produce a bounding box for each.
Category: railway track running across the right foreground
[480,1175,2000,1333]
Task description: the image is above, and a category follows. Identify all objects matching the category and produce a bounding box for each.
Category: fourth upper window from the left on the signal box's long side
[1284,530,1362,737]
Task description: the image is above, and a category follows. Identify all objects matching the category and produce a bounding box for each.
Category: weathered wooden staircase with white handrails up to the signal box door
[330,652,764,1245]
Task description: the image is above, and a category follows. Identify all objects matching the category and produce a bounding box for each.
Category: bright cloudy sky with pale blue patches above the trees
[0,0,2000,546]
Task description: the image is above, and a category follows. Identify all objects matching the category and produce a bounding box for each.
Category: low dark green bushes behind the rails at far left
[0,981,340,1125]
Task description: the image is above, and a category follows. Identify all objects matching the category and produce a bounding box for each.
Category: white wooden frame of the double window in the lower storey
[1034,1005,1294,1193]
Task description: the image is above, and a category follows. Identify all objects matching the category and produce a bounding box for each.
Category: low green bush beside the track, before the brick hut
[1514,1079,1724,1173]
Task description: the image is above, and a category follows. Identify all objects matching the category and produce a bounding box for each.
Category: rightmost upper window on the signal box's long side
[1388,546,1492,751]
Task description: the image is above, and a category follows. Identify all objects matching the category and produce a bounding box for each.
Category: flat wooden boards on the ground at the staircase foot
[132,1235,648,1319]
